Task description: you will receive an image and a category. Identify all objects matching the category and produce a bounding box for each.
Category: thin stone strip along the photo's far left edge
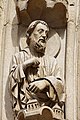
[0,0,4,119]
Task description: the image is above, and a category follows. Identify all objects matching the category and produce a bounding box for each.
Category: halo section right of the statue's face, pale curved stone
[45,30,61,57]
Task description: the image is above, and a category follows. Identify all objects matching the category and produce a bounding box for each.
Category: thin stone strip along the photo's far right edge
[76,0,80,120]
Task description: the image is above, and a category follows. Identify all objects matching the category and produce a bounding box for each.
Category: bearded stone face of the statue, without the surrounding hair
[30,23,49,53]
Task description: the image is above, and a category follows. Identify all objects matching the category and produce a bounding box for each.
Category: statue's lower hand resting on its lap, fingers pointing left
[29,80,50,93]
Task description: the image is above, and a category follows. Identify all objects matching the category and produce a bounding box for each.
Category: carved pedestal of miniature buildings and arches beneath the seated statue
[17,100,64,120]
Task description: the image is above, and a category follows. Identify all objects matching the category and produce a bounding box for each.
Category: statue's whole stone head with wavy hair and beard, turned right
[26,20,49,53]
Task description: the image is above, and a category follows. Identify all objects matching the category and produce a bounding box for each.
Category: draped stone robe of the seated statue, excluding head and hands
[9,47,65,111]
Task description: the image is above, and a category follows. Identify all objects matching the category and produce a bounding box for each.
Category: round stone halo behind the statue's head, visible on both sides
[19,29,61,57]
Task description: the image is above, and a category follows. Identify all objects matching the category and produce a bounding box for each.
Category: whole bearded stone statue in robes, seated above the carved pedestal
[9,20,65,119]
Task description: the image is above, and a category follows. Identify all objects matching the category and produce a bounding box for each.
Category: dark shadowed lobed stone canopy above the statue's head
[16,0,68,28]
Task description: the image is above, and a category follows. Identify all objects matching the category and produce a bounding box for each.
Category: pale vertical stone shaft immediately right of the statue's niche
[66,0,77,120]
